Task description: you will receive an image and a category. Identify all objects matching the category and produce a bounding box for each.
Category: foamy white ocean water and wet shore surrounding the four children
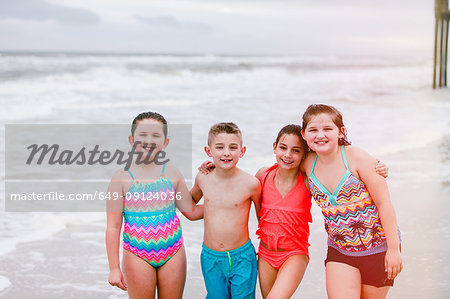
[0,53,450,298]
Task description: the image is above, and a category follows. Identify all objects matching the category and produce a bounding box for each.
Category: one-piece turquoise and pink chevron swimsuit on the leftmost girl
[123,164,183,268]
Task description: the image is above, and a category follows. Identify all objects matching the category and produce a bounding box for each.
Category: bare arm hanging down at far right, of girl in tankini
[352,148,403,279]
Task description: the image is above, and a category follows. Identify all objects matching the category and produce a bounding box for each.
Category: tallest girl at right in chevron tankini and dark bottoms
[302,105,402,298]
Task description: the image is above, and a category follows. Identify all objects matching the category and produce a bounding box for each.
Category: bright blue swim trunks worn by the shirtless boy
[200,240,258,299]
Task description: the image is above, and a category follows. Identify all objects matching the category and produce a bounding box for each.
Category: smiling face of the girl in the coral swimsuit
[273,134,306,170]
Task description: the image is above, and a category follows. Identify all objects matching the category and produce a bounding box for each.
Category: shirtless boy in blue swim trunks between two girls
[191,123,261,299]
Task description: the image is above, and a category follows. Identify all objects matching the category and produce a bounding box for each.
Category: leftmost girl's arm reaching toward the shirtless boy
[166,164,203,220]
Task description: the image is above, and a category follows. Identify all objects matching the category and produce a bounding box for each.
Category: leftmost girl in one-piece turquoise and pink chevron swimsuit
[106,112,203,299]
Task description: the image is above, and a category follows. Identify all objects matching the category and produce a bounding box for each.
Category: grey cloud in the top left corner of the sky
[0,0,100,25]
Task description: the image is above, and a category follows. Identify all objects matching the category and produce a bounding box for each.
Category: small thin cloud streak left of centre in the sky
[134,16,213,33]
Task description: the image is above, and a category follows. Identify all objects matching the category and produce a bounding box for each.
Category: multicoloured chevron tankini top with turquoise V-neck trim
[309,146,387,256]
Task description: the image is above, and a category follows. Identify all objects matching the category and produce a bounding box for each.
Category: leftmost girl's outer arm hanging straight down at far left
[105,171,127,291]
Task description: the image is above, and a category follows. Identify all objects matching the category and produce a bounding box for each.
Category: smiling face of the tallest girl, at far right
[302,113,345,153]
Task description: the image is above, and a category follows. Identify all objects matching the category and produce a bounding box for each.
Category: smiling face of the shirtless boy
[205,133,246,169]
